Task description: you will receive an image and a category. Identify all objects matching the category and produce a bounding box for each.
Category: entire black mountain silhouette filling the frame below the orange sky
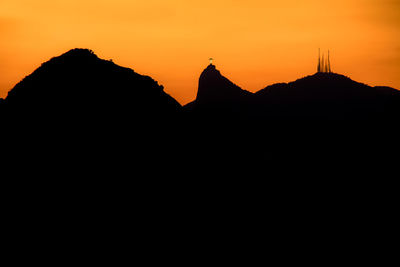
[0,52,400,253]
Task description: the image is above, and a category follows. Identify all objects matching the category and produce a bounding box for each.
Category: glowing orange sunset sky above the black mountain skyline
[0,0,400,104]
